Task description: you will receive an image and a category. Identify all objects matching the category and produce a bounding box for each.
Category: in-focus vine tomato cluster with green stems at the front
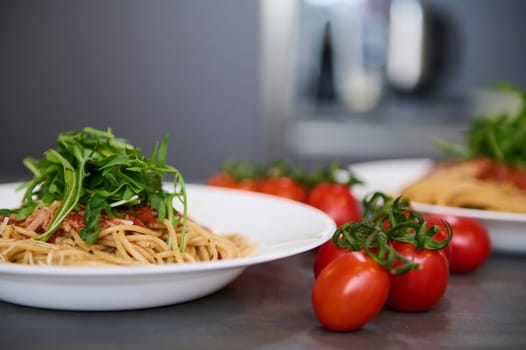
[311,193,491,332]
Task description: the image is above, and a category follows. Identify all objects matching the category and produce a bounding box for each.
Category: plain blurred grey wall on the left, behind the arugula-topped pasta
[0,0,262,180]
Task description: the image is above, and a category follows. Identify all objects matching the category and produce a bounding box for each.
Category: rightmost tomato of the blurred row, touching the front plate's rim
[307,183,361,226]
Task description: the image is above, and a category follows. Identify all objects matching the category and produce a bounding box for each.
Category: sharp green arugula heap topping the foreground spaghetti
[0,128,187,250]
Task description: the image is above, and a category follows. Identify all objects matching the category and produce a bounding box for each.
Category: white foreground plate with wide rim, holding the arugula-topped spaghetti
[0,184,336,310]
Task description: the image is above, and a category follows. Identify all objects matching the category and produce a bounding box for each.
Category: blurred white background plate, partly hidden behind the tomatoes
[350,159,526,254]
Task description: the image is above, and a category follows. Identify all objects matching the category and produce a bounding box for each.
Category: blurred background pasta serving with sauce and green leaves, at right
[402,82,526,213]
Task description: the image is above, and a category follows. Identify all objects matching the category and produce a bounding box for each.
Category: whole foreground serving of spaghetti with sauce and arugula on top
[0,128,254,266]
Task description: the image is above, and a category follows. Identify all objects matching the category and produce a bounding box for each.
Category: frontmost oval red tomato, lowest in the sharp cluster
[311,252,389,332]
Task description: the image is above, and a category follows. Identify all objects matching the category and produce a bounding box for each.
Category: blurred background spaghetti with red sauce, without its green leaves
[401,159,526,213]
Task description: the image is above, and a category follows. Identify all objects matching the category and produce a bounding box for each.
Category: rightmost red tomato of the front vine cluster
[426,214,491,273]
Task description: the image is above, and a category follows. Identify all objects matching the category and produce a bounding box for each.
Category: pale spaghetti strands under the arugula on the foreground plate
[0,208,255,266]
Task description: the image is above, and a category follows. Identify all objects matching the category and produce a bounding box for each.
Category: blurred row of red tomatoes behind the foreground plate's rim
[207,161,361,226]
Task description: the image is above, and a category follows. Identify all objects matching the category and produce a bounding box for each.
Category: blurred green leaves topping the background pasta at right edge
[437,82,526,166]
